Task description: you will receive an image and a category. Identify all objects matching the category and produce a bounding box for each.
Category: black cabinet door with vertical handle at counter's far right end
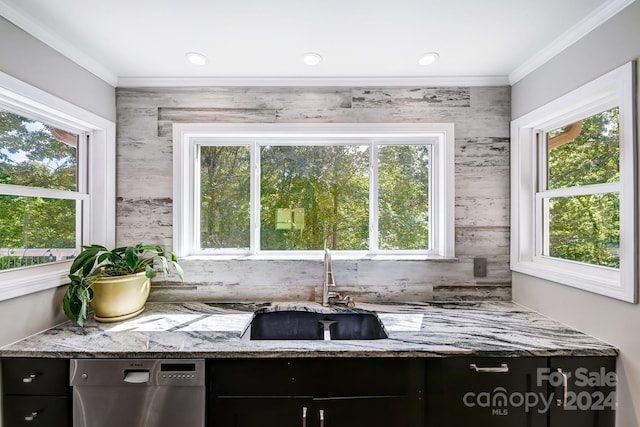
[547,357,616,427]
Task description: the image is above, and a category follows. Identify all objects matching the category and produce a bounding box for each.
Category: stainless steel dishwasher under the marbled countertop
[70,359,205,427]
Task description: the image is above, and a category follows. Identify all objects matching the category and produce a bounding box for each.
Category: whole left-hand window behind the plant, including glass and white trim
[0,73,115,300]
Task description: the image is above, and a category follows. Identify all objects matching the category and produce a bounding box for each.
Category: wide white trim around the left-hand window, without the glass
[0,72,116,301]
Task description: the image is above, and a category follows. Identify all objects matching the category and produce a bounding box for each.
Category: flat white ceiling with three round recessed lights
[0,0,633,86]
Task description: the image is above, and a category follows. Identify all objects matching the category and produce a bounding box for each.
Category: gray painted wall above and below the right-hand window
[512,2,640,427]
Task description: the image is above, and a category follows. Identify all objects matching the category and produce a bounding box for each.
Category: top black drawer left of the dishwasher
[2,358,69,396]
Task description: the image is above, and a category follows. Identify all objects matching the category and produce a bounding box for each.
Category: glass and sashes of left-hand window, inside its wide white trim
[0,108,89,270]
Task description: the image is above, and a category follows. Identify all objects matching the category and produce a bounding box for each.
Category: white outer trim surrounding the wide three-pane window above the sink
[173,123,455,258]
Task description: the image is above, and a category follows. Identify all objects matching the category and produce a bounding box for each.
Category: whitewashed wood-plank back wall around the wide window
[116,86,511,302]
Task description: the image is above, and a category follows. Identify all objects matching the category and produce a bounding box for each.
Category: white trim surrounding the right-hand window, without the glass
[511,62,637,303]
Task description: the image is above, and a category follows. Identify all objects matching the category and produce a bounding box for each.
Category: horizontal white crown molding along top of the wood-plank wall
[117,76,509,87]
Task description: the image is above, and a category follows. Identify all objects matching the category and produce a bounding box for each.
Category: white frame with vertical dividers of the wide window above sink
[173,123,455,259]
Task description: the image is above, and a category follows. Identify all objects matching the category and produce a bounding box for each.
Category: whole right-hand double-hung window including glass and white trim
[511,63,636,302]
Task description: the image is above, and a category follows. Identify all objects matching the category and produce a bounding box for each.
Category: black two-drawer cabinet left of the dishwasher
[2,358,71,427]
